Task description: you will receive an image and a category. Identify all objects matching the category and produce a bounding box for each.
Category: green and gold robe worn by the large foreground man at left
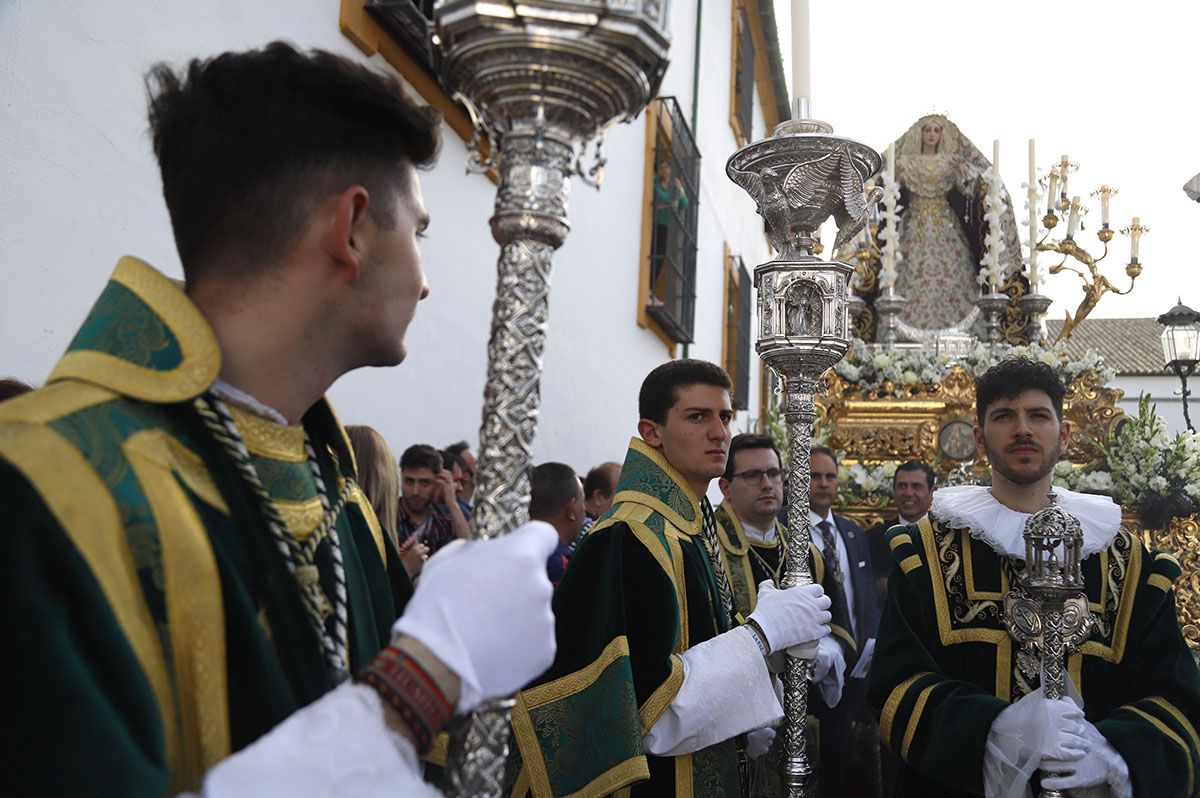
[0,258,412,796]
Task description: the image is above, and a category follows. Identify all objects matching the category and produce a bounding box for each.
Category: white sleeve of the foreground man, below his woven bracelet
[203,683,442,798]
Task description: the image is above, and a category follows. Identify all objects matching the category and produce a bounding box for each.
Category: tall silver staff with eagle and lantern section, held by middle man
[725,110,882,798]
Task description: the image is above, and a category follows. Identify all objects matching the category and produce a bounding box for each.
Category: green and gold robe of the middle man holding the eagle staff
[509,438,740,798]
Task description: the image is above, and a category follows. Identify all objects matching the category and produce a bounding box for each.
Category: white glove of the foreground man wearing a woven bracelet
[391,521,558,713]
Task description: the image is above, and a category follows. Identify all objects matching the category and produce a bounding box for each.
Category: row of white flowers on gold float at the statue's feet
[834,338,1116,396]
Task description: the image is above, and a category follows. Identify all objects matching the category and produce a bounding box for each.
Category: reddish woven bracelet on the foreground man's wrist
[358,646,454,754]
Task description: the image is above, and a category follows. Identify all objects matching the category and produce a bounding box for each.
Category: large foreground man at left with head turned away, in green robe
[0,43,553,796]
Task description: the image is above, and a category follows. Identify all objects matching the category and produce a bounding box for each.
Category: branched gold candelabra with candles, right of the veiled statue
[1022,151,1150,340]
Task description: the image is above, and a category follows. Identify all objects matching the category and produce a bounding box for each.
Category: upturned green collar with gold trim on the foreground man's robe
[47,257,221,403]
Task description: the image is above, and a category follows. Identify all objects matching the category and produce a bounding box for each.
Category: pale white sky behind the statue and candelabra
[775,0,1200,318]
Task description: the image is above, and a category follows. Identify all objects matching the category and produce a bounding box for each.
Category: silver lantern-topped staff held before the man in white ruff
[1004,491,1094,798]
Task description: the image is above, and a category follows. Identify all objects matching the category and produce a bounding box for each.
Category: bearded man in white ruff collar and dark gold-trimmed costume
[870,358,1200,798]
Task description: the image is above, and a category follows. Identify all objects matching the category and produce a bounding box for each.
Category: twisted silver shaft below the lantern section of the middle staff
[782,376,817,798]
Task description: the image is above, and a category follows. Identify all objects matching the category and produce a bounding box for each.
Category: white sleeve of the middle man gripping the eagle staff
[643,628,784,756]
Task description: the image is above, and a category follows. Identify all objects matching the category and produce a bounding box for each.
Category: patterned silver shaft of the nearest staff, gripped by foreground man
[446,120,574,798]
